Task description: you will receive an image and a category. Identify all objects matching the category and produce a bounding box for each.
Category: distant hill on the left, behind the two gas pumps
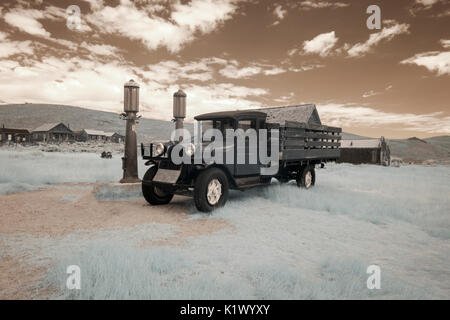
[0,104,193,141]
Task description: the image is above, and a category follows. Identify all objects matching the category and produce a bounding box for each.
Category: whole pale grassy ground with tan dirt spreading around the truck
[0,151,450,299]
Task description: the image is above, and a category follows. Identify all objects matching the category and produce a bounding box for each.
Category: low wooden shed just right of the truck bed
[338,137,391,166]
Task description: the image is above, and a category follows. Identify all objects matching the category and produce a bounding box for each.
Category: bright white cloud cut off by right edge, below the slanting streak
[401,51,450,76]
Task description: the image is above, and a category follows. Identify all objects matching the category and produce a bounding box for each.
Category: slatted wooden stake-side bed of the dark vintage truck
[271,121,342,161]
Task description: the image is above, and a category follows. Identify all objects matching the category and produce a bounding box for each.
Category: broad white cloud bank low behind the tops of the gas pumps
[0,57,268,120]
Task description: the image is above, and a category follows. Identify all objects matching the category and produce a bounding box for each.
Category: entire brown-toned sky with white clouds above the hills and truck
[0,0,450,138]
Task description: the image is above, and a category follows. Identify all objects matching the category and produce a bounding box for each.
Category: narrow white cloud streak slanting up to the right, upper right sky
[347,22,409,57]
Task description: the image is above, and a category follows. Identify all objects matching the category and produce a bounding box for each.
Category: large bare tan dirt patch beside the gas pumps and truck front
[0,182,229,238]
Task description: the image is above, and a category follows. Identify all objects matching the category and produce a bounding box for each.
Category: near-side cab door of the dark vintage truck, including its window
[235,119,260,176]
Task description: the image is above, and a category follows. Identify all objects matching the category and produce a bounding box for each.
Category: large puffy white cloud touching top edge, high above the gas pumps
[86,0,237,52]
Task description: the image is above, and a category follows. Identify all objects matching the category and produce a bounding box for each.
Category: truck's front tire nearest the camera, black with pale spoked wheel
[194,168,229,212]
